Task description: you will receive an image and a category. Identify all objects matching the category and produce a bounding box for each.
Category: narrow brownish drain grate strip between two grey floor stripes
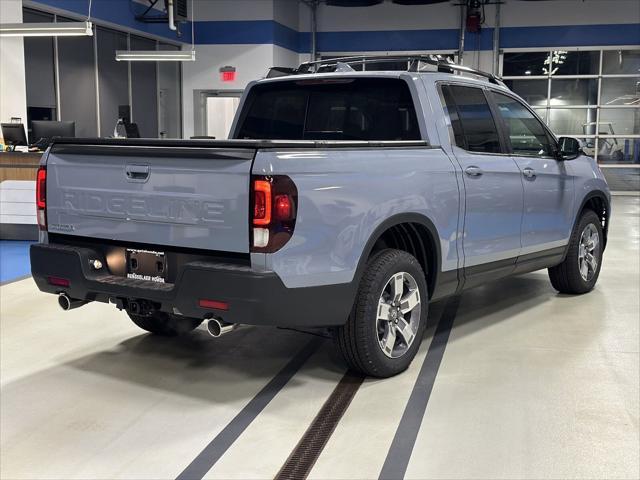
[274,372,364,480]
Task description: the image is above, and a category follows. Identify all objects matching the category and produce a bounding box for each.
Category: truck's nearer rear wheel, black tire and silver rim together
[337,249,429,378]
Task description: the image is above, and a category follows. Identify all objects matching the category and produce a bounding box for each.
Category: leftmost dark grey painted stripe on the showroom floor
[177,338,323,480]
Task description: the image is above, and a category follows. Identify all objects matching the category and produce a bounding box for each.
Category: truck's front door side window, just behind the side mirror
[493,92,555,157]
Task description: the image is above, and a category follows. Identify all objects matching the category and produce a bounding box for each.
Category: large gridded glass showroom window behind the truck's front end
[502,49,640,163]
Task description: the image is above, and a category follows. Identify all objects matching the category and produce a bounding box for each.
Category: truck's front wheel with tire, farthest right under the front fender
[549,210,604,295]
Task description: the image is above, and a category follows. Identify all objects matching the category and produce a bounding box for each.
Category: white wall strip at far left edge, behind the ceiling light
[0,0,27,133]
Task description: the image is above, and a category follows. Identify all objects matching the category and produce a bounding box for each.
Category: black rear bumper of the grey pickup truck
[30,244,355,327]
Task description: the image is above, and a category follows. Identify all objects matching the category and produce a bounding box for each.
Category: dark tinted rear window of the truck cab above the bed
[236,78,420,140]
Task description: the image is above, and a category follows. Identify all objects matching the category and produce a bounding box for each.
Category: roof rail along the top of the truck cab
[267,55,505,87]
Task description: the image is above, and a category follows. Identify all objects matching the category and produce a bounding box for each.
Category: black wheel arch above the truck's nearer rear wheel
[355,213,442,297]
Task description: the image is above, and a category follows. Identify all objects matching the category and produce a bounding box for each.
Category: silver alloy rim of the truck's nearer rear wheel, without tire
[376,272,422,358]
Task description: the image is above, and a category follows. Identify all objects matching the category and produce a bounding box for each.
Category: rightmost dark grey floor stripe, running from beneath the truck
[379,297,459,480]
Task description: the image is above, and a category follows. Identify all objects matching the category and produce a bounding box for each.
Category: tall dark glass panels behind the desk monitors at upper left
[23,8,182,141]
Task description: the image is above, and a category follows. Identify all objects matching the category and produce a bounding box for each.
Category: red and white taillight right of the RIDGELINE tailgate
[251,175,298,253]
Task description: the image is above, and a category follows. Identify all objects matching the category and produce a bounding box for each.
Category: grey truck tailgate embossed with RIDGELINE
[47,144,255,253]
